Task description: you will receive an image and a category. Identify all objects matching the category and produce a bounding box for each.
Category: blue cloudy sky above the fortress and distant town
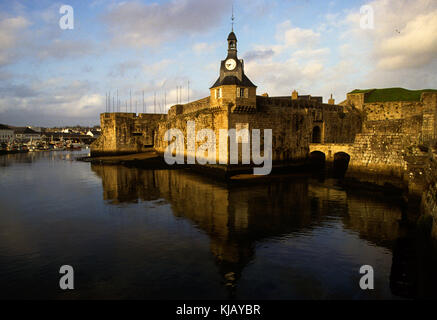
[0,0,437,127]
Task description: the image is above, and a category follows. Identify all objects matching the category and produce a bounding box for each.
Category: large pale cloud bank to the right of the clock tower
[246,0,437,101]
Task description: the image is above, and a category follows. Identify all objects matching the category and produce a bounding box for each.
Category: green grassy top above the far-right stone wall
[349,88,437,103]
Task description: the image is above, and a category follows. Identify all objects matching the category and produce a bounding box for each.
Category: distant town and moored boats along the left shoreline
[0,124,100,153]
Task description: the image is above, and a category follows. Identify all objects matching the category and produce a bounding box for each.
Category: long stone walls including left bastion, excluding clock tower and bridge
[92,89,361,163]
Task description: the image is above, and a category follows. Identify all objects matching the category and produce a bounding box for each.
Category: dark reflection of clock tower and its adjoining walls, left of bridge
[91,165,316,296]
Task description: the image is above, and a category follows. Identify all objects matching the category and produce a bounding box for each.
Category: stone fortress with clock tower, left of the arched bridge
[92,32,362,163]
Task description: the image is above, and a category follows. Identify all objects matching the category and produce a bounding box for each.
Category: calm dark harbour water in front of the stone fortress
[0,152,437,299]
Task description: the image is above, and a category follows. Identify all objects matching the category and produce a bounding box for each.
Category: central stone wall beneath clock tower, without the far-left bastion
[155,96,361,163]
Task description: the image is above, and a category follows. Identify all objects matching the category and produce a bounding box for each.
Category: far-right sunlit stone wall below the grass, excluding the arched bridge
[340,93,437,182]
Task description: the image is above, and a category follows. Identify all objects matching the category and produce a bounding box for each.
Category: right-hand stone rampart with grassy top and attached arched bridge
[310,88,437,195]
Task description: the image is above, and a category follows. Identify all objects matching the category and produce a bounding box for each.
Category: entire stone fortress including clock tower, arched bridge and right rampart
[91,32,437,240]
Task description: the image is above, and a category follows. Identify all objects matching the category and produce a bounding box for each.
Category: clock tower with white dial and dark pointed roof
[210,31,256,112]
